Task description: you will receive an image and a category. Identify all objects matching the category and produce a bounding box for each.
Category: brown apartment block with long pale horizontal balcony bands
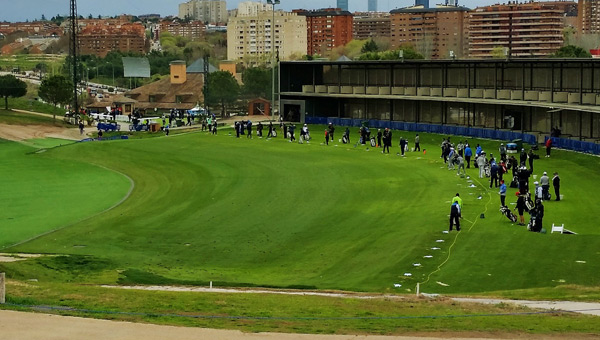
[468,1,575,58]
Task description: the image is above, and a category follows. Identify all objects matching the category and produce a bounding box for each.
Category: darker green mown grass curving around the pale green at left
[4,128,600,295]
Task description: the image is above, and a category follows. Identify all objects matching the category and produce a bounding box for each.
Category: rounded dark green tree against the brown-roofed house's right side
[204,71,240,117]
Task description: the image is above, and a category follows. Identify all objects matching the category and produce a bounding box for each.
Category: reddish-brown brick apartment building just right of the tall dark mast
[78,23,147,57]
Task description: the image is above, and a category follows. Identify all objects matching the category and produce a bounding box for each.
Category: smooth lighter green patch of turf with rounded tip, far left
[0,140,130,249]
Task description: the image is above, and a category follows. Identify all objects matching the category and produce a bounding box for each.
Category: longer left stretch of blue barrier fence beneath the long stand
[305,117,537,145]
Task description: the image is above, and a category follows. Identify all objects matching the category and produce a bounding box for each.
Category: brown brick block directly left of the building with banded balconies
[390,6,469,59]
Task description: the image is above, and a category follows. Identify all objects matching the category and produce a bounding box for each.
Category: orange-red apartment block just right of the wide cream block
[293,8,353,55]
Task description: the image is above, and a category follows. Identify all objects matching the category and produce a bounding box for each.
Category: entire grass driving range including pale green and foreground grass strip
[0,119,600,334]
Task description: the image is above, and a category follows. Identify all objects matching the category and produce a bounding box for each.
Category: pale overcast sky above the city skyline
[0,0,501,22]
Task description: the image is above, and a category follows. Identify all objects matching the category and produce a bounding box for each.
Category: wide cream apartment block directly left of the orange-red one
[227,3,307,65]
